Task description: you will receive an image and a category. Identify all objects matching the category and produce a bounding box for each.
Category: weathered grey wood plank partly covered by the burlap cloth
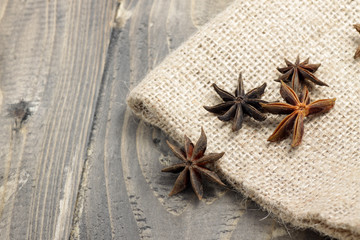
[78,0,321,240]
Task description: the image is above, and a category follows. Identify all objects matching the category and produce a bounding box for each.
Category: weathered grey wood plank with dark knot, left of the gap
[0,0,117,239]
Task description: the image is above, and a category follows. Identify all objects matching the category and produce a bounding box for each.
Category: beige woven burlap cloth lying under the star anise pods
[128,0,360,239]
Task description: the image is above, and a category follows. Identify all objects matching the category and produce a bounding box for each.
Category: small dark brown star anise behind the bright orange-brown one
[277,56,328,93]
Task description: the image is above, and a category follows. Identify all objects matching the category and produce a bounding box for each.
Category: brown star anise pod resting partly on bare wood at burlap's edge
[161,128,225,200]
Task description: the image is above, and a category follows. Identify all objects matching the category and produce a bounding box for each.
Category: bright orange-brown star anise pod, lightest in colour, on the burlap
[261,81,336,147]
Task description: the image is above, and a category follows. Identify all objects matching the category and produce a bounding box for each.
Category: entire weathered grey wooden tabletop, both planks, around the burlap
[0,0,322,239]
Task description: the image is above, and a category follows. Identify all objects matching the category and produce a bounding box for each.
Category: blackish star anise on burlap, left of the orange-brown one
[204,73,266,131]
